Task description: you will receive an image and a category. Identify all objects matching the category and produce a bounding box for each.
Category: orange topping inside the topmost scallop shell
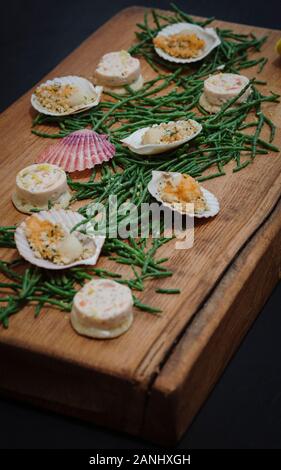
[153,32,205,59]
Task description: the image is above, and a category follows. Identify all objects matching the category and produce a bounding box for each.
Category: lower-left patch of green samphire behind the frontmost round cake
[0,235,168,328]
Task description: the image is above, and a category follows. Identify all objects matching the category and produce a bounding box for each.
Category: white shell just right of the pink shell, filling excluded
[121,119,202,155]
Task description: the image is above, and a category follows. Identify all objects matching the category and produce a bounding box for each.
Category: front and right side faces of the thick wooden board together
[0,197,281,445]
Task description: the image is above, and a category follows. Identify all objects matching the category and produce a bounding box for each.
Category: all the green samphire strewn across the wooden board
[0,4,279,326]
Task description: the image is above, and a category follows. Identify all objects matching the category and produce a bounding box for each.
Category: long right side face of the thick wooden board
[141,197,281,445]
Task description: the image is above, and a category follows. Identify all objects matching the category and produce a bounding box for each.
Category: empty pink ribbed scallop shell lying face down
[37,129,115,173]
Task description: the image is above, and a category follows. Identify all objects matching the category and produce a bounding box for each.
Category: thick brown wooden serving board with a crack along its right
[0,7,281,444]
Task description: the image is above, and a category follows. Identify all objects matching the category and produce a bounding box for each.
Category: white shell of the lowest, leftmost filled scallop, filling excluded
[15,209,105,270]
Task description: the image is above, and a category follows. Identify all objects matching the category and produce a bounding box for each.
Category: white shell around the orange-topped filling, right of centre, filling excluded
[147,171,220,219]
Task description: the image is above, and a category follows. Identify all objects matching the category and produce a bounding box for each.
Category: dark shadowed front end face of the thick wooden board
[0,343,146,435]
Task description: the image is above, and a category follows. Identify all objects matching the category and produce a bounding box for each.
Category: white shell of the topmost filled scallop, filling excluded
[155,23,221,64]
